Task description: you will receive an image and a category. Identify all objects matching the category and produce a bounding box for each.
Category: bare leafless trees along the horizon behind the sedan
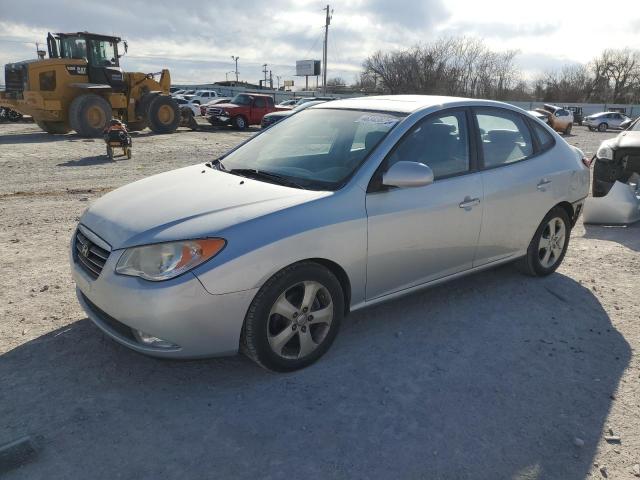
[355,37,640,103]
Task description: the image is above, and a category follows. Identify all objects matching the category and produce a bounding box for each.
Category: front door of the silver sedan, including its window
[366,109,483,300]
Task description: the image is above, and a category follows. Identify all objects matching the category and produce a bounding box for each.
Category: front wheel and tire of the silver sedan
[241,262,344,372]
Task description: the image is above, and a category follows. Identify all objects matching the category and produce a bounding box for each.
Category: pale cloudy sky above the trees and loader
[0,0,640,84]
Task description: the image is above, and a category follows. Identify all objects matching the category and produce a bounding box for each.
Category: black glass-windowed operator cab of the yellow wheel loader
[47,32,127,93]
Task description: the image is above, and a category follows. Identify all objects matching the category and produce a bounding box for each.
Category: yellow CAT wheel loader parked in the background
[0,32,181,137]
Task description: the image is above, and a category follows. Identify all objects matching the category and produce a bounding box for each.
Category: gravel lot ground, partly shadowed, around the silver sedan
[0,124,640,480]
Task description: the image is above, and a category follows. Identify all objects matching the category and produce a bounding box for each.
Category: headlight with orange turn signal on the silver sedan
[116,238,226,282]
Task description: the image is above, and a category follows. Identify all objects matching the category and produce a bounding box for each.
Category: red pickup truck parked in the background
[205,93,290,130]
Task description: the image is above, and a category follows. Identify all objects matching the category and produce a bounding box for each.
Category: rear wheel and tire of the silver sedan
[518,207,571,277]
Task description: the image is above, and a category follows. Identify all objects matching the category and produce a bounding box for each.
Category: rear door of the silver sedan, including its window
[474,107,561,267]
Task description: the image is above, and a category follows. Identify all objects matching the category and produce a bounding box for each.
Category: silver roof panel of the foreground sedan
[312,95,518,114]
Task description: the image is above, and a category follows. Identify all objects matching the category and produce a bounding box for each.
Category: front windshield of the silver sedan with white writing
[222,108,402,190]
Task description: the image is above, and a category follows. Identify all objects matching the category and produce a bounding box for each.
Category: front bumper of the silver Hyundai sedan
[71,238,257,359]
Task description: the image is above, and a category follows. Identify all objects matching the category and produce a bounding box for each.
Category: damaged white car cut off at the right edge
[591,119,640,197]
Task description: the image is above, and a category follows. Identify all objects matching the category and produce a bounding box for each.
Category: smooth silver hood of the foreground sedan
[80,164,331,250]
